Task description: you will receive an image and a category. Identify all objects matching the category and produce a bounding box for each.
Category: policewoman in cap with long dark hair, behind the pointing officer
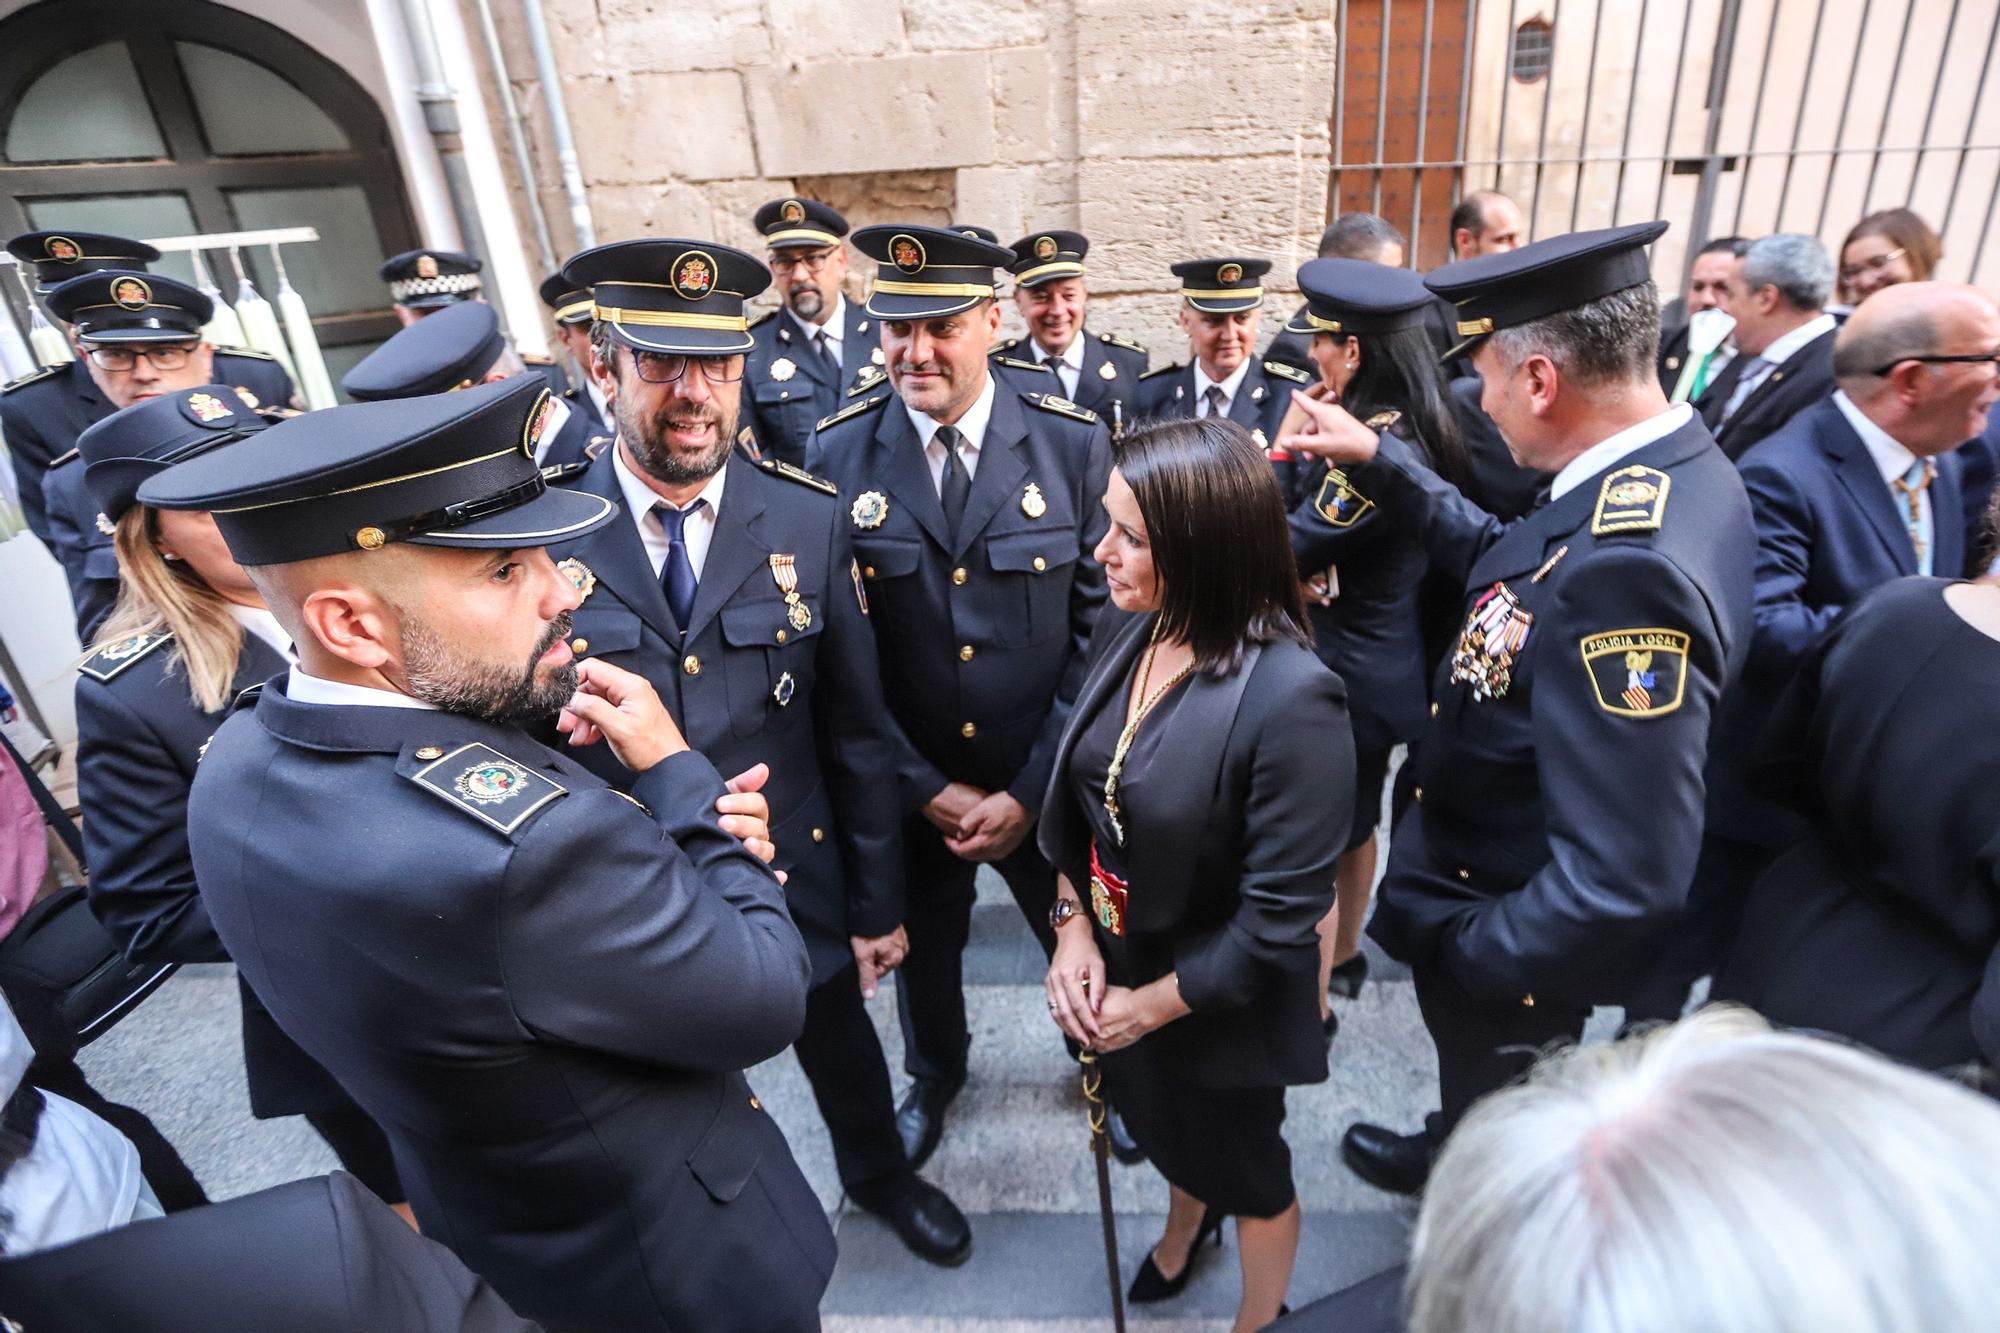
[1280,258,1468,1016]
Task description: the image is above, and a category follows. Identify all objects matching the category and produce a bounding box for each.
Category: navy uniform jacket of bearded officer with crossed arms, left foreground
[188,681,834,1329]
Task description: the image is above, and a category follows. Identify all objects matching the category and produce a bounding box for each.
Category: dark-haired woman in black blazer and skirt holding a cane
[1040,418,1354,1329]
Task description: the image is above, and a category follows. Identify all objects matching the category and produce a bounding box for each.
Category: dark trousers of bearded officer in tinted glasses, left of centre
[792,951,914,1189]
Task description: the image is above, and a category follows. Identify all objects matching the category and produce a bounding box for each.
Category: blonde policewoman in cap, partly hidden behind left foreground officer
[76,384,406,1211]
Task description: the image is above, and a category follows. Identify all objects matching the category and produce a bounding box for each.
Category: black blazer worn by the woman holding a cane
[1038,614,1354,1087]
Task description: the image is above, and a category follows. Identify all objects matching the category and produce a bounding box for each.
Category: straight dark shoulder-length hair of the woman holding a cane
[1112,416,1312,677]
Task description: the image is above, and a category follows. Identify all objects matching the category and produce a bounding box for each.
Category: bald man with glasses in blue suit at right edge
[1628,282,2000,1019]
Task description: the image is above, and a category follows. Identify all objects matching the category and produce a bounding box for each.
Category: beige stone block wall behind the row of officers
[462,0,1334,364]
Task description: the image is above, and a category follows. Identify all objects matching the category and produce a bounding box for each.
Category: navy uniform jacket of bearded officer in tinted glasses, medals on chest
[550,450,908,983]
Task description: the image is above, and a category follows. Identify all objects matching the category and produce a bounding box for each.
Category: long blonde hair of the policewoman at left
[90,504,244,713]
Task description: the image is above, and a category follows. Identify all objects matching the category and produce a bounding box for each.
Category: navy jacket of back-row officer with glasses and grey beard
[744,300,882,466]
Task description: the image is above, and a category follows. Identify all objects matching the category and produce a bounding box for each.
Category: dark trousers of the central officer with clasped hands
[896,815,1056,1083]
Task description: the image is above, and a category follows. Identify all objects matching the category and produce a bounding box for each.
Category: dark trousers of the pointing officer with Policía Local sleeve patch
[1410,948,1590,1145]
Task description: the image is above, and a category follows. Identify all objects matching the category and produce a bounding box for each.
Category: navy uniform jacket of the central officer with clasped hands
[810,382,1110,813]
